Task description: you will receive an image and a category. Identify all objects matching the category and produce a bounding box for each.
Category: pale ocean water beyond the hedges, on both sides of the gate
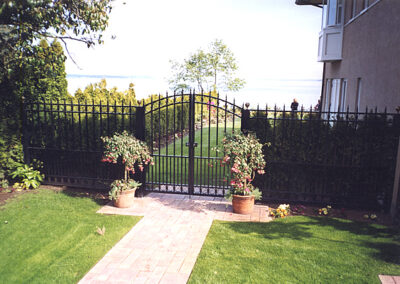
[67,75,322,108]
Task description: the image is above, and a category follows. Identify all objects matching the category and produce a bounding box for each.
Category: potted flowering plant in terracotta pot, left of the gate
[101,131,154,208]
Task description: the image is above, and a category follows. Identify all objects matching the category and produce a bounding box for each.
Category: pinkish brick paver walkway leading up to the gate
[79,193,270,284]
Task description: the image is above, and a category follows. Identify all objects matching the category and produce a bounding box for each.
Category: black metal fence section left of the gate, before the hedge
[23,101,144,188]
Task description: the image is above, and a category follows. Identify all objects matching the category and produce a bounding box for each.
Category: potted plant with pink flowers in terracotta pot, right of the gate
[221,133,265,214]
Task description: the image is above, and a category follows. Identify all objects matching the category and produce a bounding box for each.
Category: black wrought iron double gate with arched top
[144,93,241,196]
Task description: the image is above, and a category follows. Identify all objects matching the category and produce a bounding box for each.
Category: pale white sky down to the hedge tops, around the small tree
[66,0,322,106]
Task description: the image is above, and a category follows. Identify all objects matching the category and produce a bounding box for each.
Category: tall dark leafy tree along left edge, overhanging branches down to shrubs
[0,0,112,175]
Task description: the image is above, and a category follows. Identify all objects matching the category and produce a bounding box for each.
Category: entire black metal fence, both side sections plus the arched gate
[23,97,400,211]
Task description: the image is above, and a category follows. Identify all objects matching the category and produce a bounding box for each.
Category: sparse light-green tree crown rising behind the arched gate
[168,40,245,91]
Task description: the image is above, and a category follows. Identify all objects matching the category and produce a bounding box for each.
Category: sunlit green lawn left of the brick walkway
[0,190,140,283]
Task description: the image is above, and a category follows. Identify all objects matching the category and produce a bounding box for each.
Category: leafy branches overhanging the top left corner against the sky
[0,0,111,80]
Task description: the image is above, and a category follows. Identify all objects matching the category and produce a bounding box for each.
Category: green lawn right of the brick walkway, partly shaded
[189,216,400,283]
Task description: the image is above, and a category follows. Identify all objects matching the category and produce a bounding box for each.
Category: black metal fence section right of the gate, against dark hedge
[244,107,400,211]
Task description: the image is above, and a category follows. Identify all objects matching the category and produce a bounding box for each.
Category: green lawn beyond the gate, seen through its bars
[147,121,240,187]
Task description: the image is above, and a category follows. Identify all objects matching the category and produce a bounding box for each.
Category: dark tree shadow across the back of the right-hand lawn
[226,217,400,264]
